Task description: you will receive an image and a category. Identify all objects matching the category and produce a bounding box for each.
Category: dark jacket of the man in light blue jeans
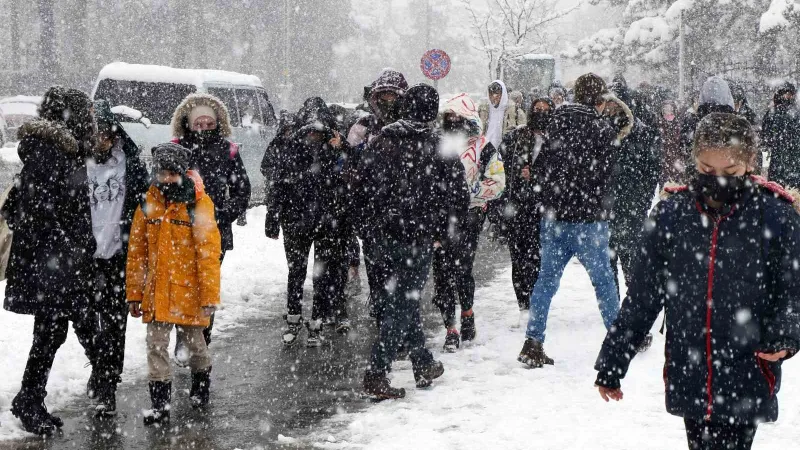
[539,104,617,223]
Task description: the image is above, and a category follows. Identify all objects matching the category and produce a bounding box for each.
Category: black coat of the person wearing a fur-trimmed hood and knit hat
[177,133,250,251]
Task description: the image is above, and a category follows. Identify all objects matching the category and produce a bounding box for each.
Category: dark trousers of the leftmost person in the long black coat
[19,311,94,401]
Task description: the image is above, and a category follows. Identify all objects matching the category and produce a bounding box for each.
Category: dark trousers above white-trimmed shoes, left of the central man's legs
[283,230,347,320]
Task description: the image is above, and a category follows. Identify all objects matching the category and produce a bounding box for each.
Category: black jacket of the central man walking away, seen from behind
[351,120,469,244]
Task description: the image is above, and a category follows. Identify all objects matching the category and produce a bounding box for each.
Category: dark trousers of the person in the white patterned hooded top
[433,209,486,328]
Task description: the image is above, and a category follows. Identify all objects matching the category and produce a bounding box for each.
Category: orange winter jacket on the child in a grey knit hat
[127,171,221,327]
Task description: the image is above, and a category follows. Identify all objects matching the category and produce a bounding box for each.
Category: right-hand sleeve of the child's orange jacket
[192,196,222,306]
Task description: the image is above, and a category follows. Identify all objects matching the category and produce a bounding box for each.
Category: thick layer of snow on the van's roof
[98,62,263,87]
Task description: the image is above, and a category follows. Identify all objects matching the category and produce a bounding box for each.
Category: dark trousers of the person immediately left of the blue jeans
[508,211,542,311]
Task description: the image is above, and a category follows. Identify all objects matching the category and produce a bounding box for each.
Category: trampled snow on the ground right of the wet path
[310,260,800,450]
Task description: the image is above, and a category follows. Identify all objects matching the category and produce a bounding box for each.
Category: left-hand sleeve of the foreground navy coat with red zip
[594,203,668,388]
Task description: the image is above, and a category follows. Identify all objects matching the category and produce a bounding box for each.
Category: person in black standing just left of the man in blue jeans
[500,97,556,316]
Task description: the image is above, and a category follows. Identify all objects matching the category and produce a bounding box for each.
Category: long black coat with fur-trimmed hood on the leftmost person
[2,120,96,315]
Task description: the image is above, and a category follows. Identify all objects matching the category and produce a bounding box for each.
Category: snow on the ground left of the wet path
[0,206,288,440]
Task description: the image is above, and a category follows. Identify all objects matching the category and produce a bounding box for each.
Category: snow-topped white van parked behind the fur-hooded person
[92,62,277,204]
